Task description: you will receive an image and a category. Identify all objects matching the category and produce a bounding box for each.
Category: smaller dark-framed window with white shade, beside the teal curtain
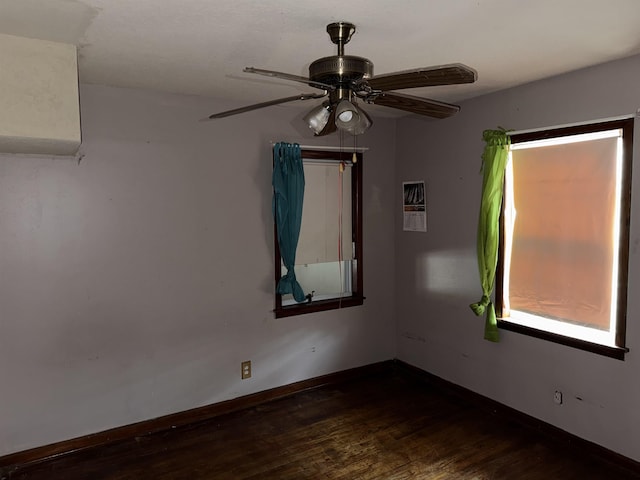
[274,149,364,318]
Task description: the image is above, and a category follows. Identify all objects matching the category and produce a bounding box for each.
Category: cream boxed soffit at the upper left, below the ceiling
[0,34,81,155]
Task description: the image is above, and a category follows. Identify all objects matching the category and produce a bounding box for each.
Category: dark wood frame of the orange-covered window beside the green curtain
[495,117,634,360]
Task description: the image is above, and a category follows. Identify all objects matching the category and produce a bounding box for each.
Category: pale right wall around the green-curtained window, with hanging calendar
[395,57,640,460]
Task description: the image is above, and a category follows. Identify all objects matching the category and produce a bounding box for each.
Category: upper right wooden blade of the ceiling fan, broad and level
[367,63,478,91]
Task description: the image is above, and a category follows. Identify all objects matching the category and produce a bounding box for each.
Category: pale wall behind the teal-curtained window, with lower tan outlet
[0,86,395,455]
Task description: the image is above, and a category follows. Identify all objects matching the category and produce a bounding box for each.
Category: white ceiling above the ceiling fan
[0,0,640,116]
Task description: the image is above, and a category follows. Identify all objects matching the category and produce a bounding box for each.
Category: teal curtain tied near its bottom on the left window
[272,142,306,302]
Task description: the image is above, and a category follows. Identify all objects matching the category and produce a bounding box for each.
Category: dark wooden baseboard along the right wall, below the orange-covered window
[394,360,640,475]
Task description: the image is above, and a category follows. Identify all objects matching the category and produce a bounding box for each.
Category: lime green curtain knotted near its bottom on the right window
[470,128,510,342]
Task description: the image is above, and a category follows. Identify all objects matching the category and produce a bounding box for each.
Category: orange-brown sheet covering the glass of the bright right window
[505,136,619,330]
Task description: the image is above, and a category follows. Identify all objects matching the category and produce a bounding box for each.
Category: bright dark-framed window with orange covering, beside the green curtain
[496,119,633,359]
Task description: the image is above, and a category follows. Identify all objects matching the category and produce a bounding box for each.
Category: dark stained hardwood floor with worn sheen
[5,369,640,480]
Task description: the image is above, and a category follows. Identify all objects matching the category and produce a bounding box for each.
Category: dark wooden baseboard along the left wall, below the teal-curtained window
[0,360,394,472]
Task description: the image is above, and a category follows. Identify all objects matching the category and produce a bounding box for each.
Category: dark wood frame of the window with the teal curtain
[273,148,365,318]
